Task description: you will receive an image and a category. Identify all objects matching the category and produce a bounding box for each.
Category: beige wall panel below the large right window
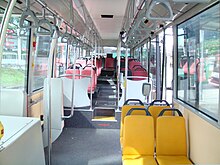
[174,103,220,164]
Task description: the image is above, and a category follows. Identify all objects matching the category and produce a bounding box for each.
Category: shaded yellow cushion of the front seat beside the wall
[157,156,193,165]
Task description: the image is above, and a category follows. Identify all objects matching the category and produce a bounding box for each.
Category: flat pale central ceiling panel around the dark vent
[84,0,128,39]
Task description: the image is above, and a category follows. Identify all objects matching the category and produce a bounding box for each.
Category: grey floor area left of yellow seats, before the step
[45,128,122,165]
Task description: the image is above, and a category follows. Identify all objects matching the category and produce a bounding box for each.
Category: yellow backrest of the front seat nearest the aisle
[122,115,154,156]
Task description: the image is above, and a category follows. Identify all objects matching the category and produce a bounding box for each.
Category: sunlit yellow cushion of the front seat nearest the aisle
[122,155,157,165]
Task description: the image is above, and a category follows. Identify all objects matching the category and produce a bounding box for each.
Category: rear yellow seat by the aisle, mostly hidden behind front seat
[120,99,145,145]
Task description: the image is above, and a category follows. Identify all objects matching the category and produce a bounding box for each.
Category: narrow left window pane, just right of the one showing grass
[33,28,51,91]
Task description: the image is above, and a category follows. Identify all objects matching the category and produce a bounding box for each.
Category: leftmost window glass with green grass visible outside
[0,12,29,89]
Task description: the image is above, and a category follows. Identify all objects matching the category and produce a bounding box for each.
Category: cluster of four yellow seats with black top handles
[120,99,192,165]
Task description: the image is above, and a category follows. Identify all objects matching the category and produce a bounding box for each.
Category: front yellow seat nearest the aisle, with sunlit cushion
[122,111,157,165]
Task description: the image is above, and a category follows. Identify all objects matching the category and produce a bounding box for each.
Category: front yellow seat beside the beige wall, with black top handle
[156,109,192,165]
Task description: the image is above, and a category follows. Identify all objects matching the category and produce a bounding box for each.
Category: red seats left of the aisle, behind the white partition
[66,59,102,93]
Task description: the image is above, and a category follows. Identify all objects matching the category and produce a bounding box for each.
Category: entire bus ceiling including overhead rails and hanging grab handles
[1,0,214,48]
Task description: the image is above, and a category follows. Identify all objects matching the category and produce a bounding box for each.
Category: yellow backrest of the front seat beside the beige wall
[156,109,187,156]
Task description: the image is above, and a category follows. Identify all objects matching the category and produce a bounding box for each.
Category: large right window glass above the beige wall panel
[177,3,220,120]
